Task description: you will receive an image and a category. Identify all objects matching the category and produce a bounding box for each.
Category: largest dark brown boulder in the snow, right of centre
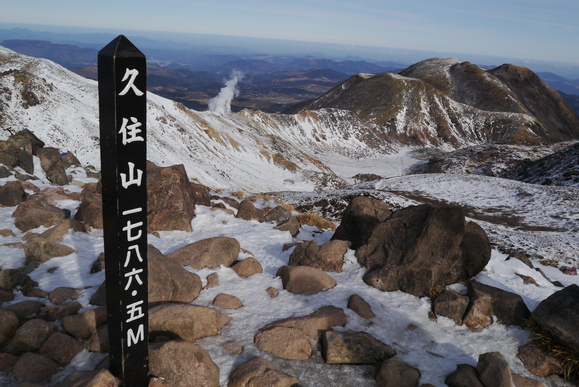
[356,204,491,297]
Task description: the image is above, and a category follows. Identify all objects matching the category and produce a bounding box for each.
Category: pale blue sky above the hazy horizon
[0,0,579,64]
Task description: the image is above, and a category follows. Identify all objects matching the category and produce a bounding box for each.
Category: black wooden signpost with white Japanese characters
[98,35,149,387]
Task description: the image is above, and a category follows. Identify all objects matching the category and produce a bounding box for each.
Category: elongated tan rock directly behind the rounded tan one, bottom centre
[260,305,347,339]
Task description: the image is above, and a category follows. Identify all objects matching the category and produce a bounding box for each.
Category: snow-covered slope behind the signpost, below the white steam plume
[0,48,406,191]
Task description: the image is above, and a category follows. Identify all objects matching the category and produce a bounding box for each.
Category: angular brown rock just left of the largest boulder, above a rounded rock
[288,240,350,273]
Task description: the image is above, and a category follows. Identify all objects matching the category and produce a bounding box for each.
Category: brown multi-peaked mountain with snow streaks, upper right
[287,58,579,148]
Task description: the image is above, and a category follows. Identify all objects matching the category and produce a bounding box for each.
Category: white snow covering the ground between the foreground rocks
[0,164,579,386]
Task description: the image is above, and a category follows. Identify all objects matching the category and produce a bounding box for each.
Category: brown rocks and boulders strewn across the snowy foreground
[0,131,579,387]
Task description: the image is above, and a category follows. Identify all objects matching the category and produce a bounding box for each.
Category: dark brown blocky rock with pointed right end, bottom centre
[322,330,396,364]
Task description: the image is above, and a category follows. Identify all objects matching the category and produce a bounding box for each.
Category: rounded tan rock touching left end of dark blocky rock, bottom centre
[255,326,312,360]
